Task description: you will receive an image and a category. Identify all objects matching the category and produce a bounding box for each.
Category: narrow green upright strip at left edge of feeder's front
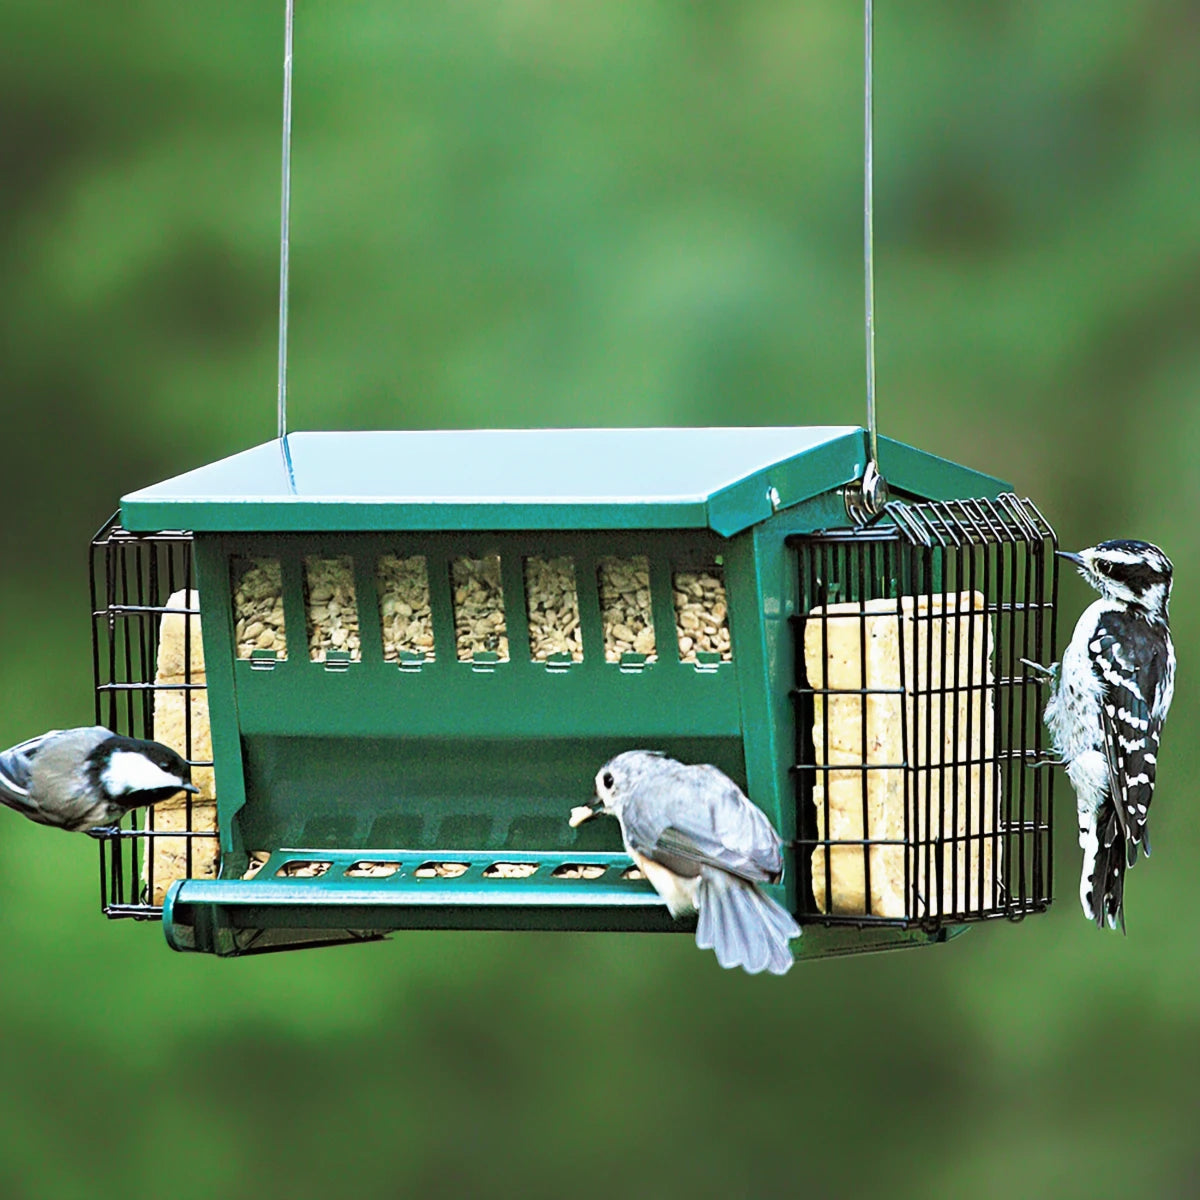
[196,535,246,856]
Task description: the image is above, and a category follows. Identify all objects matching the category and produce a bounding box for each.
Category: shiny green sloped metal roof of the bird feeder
[121,425,1006,536]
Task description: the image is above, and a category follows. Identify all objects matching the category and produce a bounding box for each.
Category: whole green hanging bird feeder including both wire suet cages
[92,427,1057,958]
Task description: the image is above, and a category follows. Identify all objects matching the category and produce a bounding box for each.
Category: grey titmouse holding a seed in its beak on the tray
[570,750,800,974]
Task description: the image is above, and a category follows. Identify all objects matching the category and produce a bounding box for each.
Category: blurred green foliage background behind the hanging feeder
[0,0,1200,1200]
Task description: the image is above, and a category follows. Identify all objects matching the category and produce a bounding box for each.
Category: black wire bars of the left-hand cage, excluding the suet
[89,516,218,919]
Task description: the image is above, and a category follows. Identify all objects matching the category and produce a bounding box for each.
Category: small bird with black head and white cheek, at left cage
[0,725,199,838]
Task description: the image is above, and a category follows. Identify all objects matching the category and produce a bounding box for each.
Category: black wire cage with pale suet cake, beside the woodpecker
[792,493,1057,929]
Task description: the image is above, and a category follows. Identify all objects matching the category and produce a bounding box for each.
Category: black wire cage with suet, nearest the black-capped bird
[89,517,218,919]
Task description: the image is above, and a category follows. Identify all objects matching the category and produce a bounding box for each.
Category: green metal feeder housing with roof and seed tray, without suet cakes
[102,427,1056,958]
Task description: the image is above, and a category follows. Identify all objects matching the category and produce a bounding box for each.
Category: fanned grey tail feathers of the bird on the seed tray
[696,870,800,974]
